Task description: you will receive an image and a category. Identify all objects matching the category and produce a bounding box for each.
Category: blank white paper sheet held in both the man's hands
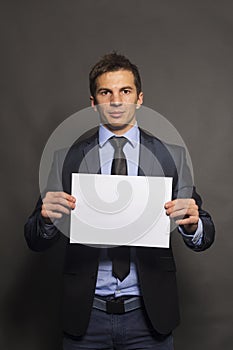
[70,174,172,248]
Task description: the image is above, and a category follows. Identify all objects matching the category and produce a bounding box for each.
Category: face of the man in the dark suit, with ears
[91,70,143,135]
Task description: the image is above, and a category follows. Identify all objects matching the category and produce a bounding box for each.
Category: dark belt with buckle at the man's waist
[93,297,142,314]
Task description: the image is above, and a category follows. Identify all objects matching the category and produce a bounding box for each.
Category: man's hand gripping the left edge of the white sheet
[41,192,76,223]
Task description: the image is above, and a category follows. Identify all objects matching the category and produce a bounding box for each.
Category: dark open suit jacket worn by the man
[25,130,214,336]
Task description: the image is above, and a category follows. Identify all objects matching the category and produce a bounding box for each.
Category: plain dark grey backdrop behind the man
[0,0,233,350]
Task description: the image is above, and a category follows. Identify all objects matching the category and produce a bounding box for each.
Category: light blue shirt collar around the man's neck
[99,122,139,148]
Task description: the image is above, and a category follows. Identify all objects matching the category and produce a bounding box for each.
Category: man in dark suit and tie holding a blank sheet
[25,53,214,350]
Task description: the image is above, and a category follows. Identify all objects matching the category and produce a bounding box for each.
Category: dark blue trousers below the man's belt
[63,308,174,350]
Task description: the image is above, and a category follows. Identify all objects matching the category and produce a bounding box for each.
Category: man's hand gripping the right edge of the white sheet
[164,198,199,233]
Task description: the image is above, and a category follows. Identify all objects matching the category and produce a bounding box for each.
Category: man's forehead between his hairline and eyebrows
[96,70,135,88]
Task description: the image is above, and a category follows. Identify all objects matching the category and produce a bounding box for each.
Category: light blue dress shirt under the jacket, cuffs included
[43,124,203,297]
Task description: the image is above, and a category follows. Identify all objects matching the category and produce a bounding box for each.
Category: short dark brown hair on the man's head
[89,52,142,98]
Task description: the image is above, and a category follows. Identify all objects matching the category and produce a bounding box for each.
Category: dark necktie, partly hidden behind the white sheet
[108,137,130,281]
